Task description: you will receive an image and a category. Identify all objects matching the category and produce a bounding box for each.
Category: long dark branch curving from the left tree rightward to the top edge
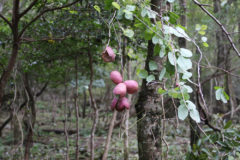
[19,0,81,38]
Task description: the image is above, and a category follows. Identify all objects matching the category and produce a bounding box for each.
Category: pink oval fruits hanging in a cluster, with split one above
[102,46,138,111]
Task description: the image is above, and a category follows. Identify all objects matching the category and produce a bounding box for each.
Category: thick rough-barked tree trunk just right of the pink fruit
[135,0,162,156]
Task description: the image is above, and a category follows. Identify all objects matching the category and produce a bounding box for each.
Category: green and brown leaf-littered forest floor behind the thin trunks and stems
[0,100,189,160]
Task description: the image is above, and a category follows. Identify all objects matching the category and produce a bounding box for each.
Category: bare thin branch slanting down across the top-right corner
[193,0,240,57]
